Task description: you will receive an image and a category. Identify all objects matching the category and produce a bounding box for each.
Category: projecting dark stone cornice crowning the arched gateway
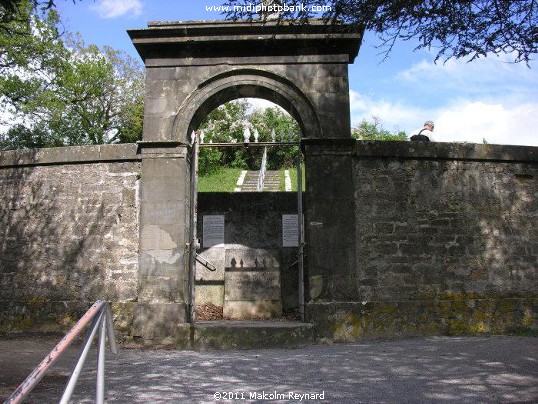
[127,20,363,66]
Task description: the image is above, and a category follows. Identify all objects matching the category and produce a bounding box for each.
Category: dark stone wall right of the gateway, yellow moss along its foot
[309,142,538,340]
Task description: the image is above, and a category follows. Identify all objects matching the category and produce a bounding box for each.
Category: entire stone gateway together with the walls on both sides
[0,17,538,345]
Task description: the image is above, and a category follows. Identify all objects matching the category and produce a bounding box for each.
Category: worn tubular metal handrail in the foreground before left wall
[4,300,118,404]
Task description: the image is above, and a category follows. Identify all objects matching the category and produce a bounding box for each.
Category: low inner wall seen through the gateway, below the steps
[196,192,298,319]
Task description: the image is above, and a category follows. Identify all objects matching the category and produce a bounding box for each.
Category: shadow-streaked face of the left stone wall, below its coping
[0,150,140,332]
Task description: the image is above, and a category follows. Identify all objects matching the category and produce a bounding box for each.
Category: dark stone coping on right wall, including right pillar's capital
[302,139,538,163]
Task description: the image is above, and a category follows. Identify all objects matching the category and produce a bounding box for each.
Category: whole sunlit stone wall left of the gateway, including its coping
[0,145,140,333]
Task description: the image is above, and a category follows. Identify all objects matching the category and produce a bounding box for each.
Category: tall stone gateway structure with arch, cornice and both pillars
[129,21,361,345]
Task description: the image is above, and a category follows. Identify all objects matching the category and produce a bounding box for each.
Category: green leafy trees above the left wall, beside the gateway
[0,2,144,149]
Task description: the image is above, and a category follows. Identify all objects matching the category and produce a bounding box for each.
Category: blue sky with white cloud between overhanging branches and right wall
[350,53,538,146]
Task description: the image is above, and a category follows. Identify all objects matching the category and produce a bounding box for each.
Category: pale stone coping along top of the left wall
[0,143,142,167]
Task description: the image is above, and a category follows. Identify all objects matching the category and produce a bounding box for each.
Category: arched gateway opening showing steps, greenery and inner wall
[189,98,304,325]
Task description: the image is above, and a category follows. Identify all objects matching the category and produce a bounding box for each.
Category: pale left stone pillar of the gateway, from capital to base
[134,145,190,340]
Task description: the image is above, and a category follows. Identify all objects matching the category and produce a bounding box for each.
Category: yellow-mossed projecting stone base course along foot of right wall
[306,296,538,342]
